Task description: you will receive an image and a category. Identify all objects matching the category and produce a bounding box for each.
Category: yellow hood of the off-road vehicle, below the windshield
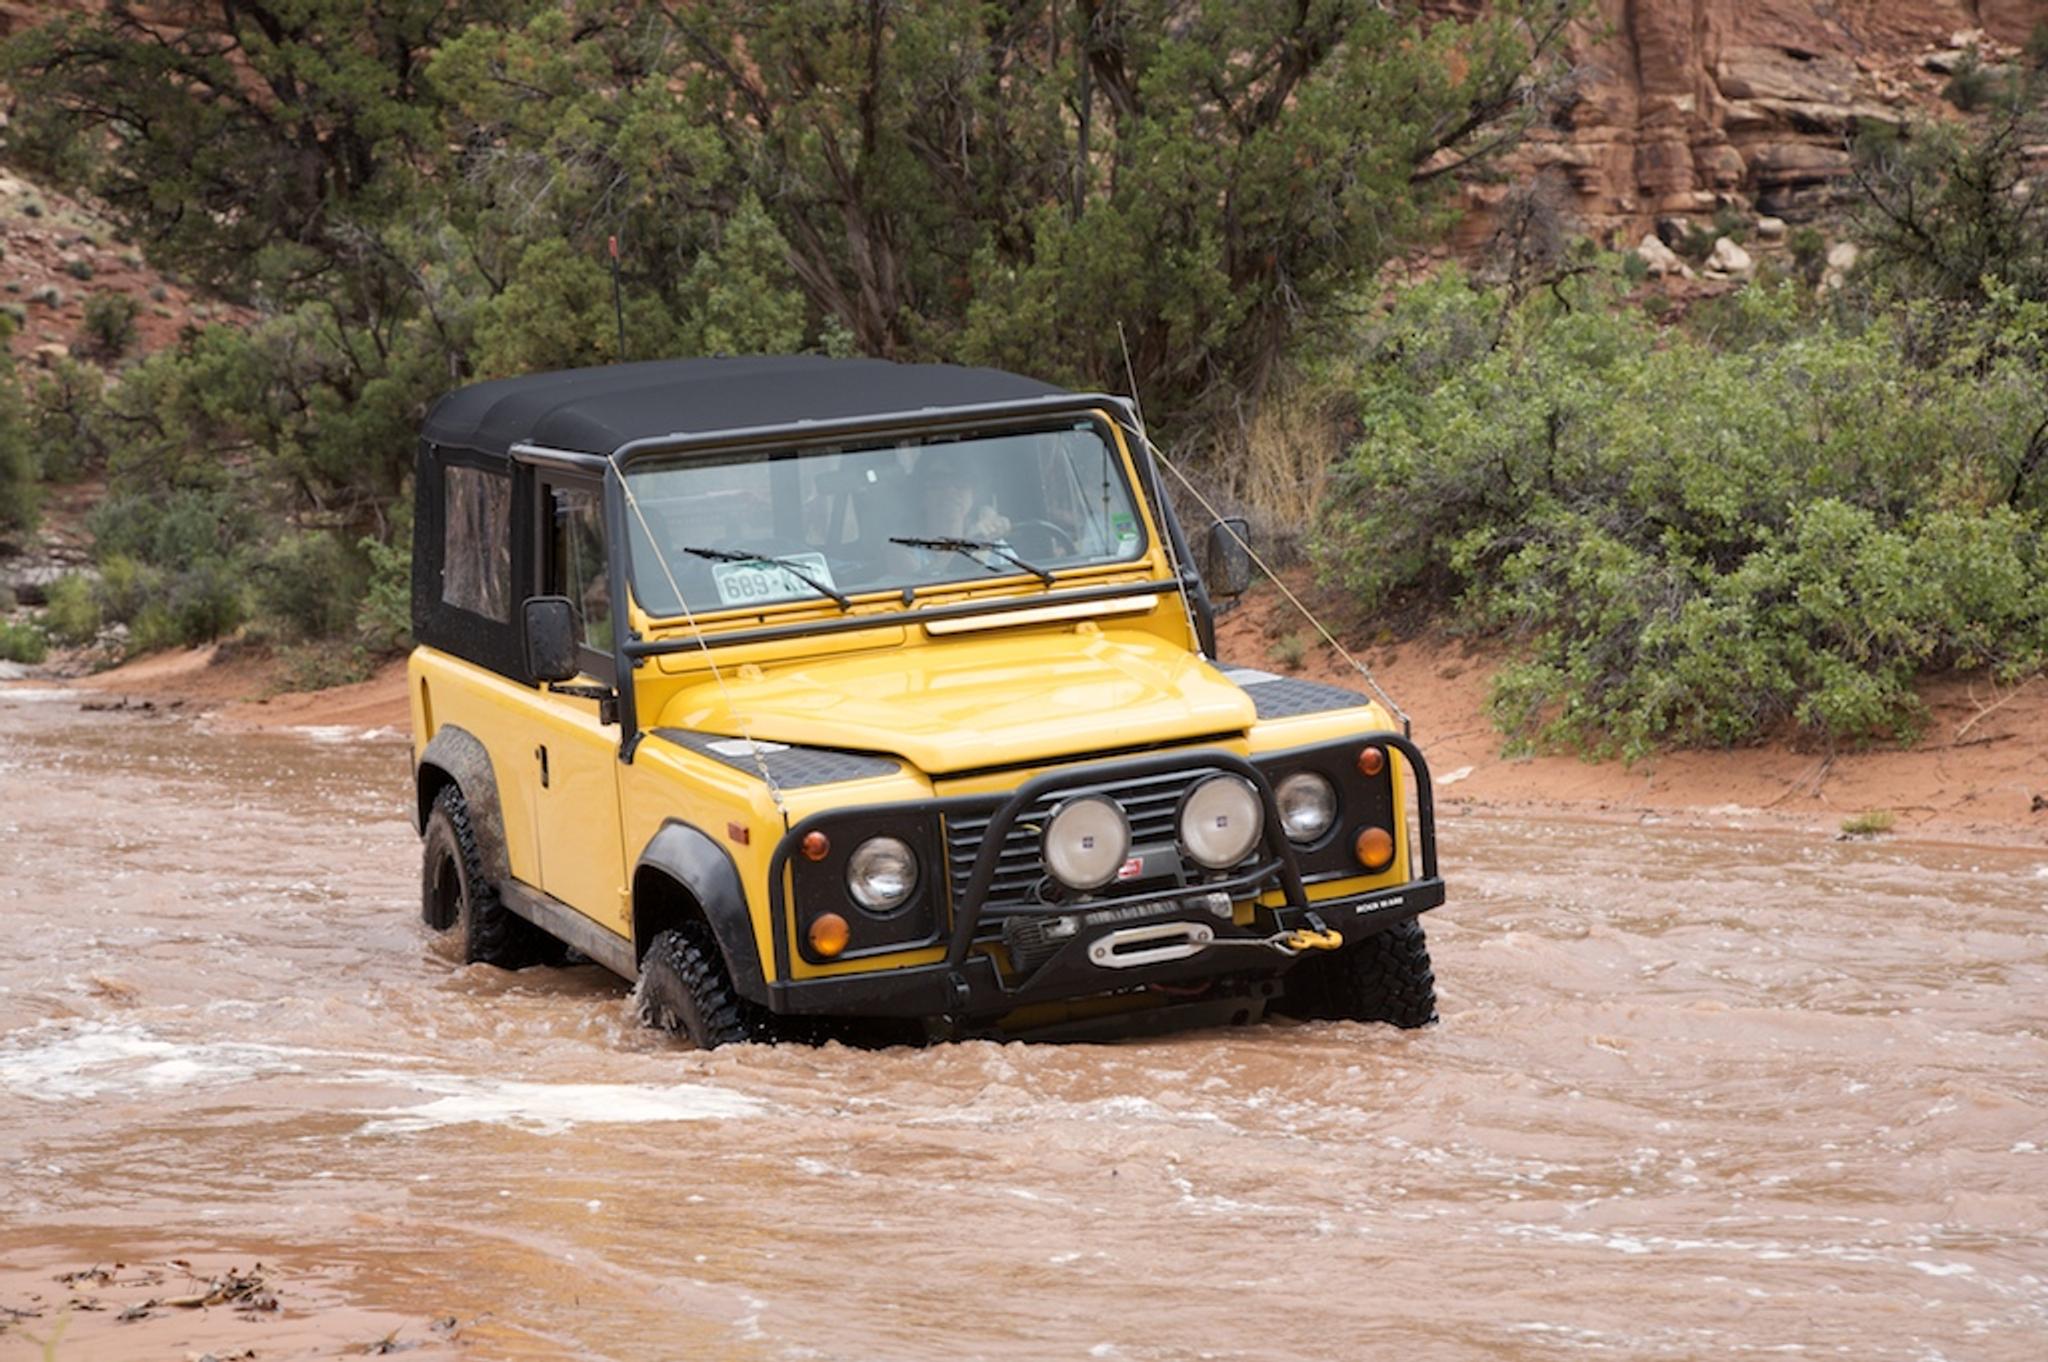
[657,633,1253,774]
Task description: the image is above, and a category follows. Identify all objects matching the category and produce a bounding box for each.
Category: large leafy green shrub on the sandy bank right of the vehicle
[1319,274,2048,756]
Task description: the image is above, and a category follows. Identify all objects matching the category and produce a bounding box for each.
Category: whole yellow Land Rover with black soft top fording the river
[410,356,1444,1047]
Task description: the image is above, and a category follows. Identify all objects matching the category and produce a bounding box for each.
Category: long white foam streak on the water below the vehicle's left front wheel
[360,1073,768,1135]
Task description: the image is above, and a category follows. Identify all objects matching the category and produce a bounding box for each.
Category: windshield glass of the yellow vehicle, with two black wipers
[627,420,1145,619]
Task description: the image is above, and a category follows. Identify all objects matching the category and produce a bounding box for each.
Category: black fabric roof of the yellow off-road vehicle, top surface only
[420,354,1065,455]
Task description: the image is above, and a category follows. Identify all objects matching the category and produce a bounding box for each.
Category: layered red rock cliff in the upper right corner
[1470,0,2048,240]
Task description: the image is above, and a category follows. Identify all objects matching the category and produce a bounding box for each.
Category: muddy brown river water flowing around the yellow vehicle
[0,688,2048,1362]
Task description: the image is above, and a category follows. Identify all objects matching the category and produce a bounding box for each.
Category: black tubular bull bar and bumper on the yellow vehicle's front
[768,731,1444,1018]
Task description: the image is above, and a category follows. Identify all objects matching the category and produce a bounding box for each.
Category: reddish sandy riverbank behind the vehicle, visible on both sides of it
[19,592,2048,846]
